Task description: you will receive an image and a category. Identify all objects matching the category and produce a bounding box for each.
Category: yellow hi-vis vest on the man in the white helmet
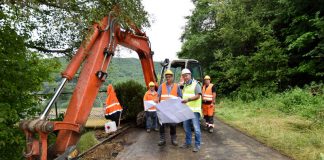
[182,80,201,114]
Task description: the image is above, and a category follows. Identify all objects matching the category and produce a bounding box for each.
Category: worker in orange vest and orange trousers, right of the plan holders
[202,75,216,133]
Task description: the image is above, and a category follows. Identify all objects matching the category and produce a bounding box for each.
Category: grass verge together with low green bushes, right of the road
[216,83,324,160]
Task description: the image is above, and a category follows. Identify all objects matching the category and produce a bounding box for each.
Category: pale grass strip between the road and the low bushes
[217,100,324,160]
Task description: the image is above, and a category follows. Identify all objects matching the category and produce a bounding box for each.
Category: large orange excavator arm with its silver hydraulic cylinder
[19,14,157,160]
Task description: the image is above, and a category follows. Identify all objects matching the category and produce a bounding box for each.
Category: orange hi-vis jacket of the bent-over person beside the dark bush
[105,84,123,115]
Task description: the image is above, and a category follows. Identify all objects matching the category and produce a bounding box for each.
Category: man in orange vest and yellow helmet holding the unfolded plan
[157,70,182,146]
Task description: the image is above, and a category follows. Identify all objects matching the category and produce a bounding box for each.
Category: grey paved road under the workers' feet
[116,120,289,160]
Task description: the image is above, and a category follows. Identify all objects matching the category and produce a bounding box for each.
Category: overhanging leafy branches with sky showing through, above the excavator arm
[0,0,150,56]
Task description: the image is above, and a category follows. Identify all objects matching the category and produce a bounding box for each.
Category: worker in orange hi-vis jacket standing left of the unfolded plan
[143,82,159,133]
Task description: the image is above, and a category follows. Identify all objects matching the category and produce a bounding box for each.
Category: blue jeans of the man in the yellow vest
[183,112,201,148]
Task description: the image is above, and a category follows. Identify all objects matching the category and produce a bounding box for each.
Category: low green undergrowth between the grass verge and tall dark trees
[227,83,324,124]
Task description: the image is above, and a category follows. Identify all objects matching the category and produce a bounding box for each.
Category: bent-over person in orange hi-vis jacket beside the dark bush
[105,84,123,126]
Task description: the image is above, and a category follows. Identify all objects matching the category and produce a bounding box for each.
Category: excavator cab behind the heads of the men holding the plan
[160,59,203,84]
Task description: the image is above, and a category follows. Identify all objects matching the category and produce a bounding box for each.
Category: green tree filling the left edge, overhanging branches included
[0,0,149,159]
